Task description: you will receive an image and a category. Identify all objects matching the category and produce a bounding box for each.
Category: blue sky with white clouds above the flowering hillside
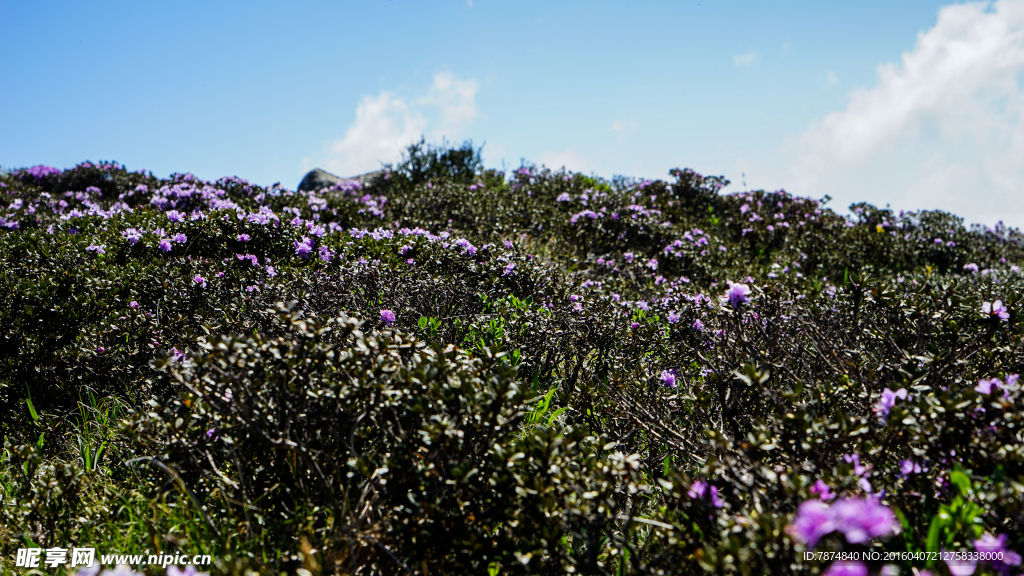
[0,0,1024,227]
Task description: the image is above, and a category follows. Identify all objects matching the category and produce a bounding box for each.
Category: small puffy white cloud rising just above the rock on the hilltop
[302,72,477,176]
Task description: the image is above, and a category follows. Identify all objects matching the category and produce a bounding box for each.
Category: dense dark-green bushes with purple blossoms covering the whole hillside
[0,142,1024,575]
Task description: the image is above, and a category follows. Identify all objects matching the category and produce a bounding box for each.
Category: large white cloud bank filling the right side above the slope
[783,0,1024,227]
